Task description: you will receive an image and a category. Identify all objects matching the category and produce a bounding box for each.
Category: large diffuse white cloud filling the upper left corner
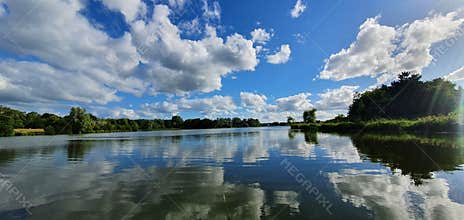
[0,0,145,103]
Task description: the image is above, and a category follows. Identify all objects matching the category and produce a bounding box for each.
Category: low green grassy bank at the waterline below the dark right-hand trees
[291,114,463,133]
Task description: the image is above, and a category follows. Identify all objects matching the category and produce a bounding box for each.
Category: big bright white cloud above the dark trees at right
[319,10,464,84]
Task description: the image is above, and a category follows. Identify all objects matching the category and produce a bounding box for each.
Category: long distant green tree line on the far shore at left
[0,106,261,136]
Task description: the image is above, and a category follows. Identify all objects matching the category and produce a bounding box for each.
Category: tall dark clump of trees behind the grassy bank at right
[348,72,462,121]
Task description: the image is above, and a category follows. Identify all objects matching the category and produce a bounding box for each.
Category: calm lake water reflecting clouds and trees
[0,127,464,219]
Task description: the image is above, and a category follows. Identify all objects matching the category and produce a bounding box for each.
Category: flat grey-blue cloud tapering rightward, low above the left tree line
[0,60,120,104]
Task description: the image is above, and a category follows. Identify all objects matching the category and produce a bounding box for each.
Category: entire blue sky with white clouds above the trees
[0,0,464,121]
